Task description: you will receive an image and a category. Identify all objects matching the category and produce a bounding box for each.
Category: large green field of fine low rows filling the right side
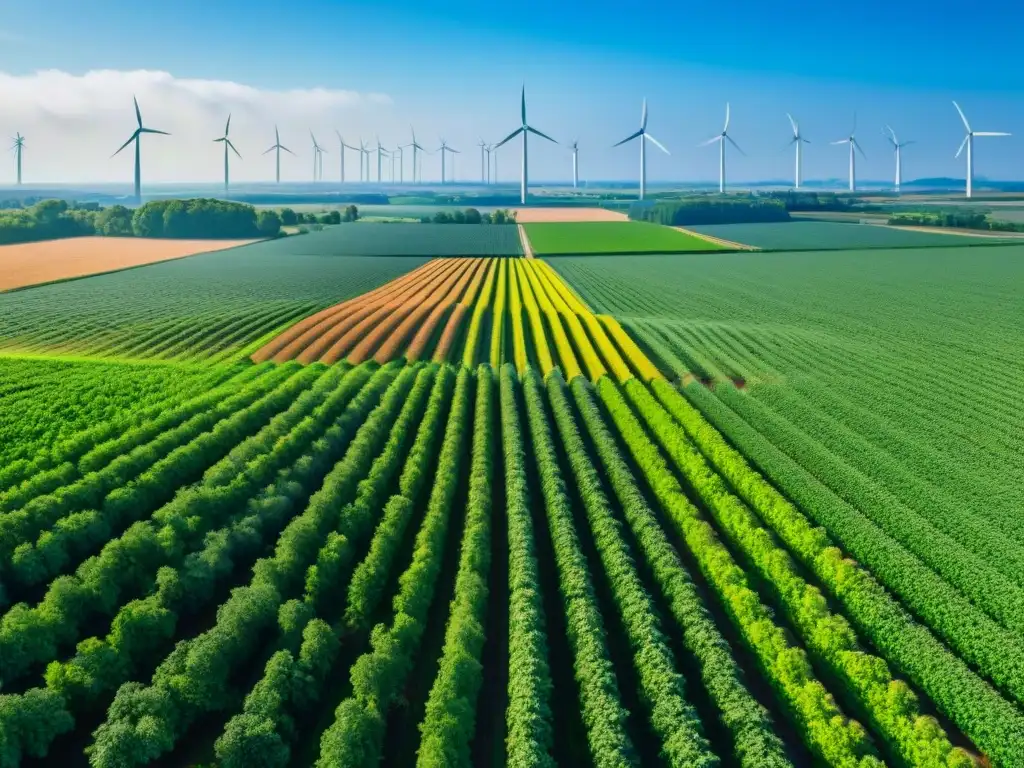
[552,247,1024,765]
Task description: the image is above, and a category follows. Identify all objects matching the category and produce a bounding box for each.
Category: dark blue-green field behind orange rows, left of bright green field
[275,221,522,257]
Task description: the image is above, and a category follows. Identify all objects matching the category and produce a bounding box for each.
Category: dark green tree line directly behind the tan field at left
[0,199,283,245]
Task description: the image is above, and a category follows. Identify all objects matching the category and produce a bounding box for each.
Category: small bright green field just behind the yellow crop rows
[522,221,722,256]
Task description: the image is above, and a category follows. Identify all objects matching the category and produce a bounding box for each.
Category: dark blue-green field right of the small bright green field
[688,220,1014,251]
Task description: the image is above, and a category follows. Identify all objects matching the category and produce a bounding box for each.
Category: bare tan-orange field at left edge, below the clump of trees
[0,238,258,291]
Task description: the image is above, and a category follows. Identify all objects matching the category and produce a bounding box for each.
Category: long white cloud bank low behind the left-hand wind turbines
[0,70,395,186]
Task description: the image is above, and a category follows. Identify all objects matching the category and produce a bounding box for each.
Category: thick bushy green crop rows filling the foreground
[0,350,1024,768]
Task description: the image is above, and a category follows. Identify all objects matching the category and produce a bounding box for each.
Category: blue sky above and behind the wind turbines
[0,0,1024,183]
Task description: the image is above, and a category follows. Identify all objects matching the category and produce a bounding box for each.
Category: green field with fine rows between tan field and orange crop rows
[0,249,423,361]
